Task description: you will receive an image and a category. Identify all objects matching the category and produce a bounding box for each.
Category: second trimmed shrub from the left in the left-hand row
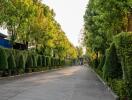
[7,53,16,70]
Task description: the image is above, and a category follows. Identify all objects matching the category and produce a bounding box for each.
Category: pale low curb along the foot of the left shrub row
[0,67,66,80]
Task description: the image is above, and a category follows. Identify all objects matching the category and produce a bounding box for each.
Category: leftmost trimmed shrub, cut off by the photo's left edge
[0,48,8,71]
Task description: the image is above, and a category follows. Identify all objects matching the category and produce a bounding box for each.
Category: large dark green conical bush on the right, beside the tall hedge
[103,43,122,80]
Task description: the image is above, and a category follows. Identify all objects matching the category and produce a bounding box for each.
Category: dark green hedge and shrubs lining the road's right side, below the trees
[91,32,132,100]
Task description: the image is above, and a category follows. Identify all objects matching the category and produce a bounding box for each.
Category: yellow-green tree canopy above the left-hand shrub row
[0,0,77,58]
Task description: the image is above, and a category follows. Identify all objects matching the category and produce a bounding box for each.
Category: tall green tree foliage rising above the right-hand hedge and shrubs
[84,0,132,68]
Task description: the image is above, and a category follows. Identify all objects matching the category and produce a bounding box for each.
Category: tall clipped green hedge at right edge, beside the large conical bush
[114,32,132,99]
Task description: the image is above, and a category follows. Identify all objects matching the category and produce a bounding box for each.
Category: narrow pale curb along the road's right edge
[89,67,119,100]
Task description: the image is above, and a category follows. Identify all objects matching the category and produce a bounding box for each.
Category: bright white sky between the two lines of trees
[42,0,88,46]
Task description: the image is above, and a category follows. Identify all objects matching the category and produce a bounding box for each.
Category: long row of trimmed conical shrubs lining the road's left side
[0,47,72,76]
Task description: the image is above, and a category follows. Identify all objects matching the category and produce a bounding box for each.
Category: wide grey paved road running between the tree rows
[0,66,115,100]
